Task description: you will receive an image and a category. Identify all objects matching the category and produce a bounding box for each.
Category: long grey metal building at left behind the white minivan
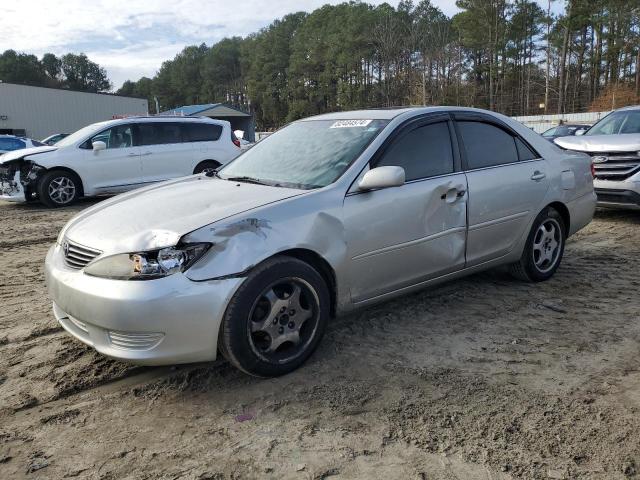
[0,82,149,140]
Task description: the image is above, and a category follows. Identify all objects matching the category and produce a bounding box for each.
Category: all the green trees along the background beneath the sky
[0,0,640,129]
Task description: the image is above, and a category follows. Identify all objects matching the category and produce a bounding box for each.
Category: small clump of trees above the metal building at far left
[0,50,112,92]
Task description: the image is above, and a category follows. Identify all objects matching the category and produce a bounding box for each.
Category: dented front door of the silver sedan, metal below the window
[344,174,467,303]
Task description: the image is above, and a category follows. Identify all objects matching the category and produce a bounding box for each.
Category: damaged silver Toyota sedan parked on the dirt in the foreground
[46,107,596,377]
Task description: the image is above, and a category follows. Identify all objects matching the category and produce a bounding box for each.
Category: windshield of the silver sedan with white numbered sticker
[219,120,388,188]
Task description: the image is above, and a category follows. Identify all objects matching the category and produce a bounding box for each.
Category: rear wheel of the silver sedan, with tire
[511,207,567,282]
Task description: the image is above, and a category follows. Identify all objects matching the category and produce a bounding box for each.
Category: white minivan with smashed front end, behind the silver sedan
[0,117,242,207]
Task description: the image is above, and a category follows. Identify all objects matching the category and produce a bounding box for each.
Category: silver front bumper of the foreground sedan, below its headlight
[45,245,244,365]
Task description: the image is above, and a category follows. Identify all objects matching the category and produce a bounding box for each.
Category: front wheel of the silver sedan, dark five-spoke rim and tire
[218,256,330,377]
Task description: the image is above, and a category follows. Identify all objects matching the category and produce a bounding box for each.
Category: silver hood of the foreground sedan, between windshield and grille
[61,175,304,254]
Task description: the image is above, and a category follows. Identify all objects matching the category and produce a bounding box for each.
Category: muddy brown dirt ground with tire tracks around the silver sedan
[0,203,640,479]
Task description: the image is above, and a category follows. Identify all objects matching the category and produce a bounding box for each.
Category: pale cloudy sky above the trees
[0,0,559,89]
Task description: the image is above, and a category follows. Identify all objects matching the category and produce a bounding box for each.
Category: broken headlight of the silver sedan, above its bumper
[84,243,211,280]
